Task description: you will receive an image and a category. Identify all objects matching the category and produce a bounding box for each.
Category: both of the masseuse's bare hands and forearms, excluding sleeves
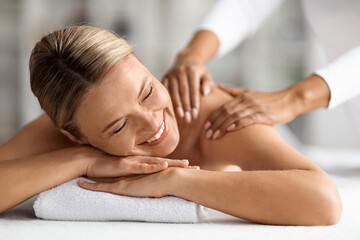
[163,30,330,139]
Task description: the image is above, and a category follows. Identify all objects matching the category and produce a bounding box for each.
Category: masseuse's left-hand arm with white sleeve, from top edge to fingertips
[163,0,282,122]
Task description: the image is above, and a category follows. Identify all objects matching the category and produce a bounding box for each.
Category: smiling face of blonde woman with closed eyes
[74,55,179,157]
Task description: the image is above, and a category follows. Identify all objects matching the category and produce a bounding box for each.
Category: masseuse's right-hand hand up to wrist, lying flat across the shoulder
[204,85,299,139]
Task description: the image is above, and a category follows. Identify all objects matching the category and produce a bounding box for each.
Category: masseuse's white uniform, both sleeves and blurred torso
[198,0,360,109]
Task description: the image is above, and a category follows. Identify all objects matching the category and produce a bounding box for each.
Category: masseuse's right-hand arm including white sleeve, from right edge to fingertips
[206,46,360,139]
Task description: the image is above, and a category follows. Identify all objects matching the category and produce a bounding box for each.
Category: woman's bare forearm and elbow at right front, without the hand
[169,169,341,225]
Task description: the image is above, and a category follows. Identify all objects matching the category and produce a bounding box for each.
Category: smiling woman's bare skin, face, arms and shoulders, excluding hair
[0,54,341,225]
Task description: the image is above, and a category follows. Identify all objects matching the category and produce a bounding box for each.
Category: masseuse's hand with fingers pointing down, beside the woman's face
[162,62,214,123]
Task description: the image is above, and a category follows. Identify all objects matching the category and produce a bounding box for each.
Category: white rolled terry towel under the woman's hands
[34,178,209,223]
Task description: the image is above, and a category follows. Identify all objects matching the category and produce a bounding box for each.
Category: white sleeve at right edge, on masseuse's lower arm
[315,45,360,109]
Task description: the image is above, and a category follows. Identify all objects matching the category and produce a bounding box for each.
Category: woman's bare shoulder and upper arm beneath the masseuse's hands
[199,89,318,170]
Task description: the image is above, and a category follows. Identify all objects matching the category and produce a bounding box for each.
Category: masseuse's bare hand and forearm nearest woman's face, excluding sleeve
[162,30,220,122]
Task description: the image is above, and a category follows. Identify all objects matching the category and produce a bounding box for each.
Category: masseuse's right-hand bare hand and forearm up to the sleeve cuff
[205,74,330,139]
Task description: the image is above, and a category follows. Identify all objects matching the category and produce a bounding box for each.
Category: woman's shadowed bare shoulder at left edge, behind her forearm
[0,114,76,160]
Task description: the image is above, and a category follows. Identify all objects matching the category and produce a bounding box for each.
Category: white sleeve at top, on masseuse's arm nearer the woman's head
[198,0,283,57]
